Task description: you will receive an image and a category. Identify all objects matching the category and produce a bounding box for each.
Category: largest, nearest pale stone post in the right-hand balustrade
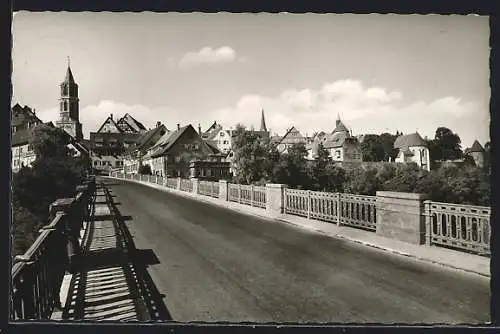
[376,191,425,245]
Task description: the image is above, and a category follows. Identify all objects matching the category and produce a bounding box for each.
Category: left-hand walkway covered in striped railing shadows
[52,186,164,321]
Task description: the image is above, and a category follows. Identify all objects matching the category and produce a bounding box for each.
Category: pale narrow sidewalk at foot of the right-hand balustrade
[108,177,491,277]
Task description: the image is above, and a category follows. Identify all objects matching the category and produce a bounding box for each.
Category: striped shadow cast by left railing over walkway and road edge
[62,185,172,321]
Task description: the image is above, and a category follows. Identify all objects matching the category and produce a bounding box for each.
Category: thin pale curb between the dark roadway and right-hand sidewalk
[104,176,491,279]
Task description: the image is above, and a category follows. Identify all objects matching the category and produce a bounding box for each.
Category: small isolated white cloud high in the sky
[178,46,242,68]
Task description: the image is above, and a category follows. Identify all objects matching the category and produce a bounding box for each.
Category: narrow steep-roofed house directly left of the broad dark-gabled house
[123,122,171,174]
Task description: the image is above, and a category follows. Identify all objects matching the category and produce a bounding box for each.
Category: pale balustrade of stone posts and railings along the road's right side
[110,173,491,255]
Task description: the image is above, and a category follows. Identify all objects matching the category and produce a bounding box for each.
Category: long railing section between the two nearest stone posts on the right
[284,189,376,231]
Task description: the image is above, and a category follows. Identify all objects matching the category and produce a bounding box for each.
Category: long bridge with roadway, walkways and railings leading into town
[10,175,490,324]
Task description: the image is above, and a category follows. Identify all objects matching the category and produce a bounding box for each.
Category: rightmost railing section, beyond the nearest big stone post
[424,201,491,255]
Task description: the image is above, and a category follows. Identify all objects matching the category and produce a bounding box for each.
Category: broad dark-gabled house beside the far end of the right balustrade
[144,124,229,179]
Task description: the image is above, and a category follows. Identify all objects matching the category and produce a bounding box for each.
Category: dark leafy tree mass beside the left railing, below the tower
[12,125,89,251]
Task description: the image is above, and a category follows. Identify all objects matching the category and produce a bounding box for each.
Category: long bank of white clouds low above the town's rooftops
[37,79,489,146]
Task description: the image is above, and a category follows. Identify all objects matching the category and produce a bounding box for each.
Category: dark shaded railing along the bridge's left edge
[10,176,95,320]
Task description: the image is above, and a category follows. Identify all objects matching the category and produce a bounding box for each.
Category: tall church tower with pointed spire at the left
[56,57,83,139]
